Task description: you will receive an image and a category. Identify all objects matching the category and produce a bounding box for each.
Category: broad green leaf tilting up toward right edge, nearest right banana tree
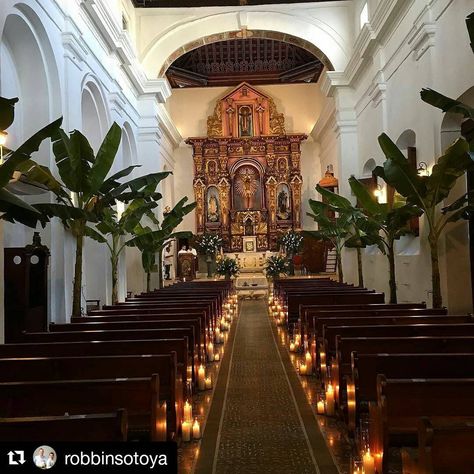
[424,138,474,207]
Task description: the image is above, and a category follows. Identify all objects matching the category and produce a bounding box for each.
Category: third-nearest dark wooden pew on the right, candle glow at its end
[343,352,474,432]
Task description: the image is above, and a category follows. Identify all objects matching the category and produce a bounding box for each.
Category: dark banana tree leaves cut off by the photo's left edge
[0,97,62,227]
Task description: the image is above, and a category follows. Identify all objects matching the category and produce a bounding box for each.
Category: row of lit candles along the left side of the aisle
[181,295,238,442]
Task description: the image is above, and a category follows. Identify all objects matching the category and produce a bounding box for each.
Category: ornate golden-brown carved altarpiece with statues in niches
[186,83,307,252]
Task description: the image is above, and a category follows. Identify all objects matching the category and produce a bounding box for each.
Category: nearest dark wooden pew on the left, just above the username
[0,408,128,443]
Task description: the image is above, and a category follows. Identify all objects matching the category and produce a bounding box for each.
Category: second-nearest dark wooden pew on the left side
[0,374,166,441]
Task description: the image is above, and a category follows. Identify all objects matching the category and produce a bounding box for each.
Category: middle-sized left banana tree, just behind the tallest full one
[91,195,161,304]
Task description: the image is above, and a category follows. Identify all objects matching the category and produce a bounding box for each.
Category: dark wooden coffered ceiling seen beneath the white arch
[166,38,324,87]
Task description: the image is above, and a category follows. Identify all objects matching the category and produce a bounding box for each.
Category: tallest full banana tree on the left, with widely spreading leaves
[16,123,172,317]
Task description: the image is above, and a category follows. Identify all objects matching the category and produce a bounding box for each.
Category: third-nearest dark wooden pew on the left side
[0,352,184,439]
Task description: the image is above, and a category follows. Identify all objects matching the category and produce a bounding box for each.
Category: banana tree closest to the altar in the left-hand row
[125,197,196,292]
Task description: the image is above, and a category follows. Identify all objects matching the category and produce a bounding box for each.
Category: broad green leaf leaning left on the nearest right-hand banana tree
[374,133,426,208]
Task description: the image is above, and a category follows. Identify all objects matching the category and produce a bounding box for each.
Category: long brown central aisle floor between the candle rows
[195,301,337,474]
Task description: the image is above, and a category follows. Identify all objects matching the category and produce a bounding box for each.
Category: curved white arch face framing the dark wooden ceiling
[141,9,349,78]
